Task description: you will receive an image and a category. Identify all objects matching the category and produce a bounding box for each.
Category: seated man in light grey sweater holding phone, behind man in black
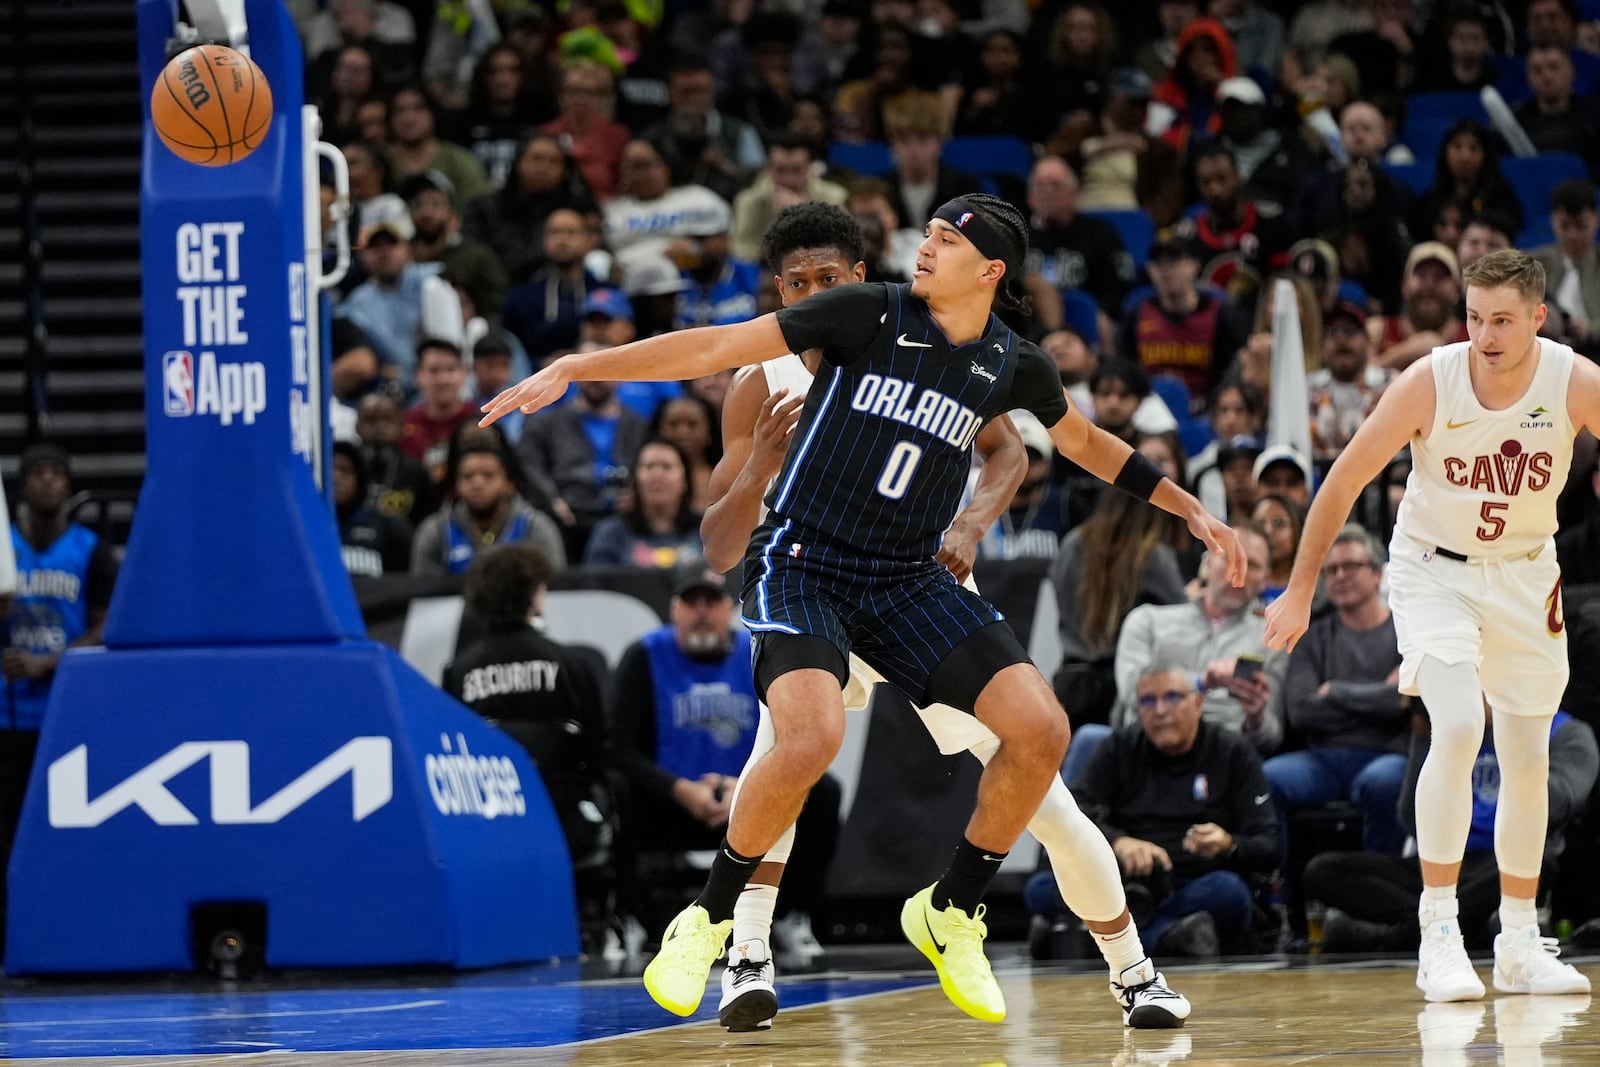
[1112,526,1288,755]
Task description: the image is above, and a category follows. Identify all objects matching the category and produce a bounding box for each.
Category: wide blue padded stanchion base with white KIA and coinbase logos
[5,641,578,974]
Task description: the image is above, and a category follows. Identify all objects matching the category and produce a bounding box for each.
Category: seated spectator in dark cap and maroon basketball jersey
[1120,237,1245,406]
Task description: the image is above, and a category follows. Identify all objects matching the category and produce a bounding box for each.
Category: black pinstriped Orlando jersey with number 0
[766,285,1067,560]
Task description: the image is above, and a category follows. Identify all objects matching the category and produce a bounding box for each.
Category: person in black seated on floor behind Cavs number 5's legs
[1304,707,1600,952]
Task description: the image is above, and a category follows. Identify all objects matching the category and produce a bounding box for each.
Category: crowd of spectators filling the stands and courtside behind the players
[0,0,1600,955]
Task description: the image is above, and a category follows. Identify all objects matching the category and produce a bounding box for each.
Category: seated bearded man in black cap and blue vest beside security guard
[611,560,840,942]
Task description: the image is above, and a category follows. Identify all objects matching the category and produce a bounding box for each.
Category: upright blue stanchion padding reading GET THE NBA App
[116,0,363,648]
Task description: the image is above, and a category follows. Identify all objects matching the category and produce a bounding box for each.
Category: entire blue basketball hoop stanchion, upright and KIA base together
[5,0,578,974]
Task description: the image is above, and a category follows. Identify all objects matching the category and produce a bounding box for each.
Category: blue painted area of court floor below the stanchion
[0,965,928,1059]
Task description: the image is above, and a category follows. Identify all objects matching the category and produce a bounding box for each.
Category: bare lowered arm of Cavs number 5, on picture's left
[1264,357,1435,651]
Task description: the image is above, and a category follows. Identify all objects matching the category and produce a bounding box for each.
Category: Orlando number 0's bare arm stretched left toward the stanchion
[478,315,789,426]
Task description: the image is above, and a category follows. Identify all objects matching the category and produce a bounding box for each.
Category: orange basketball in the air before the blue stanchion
[150,45,272,166]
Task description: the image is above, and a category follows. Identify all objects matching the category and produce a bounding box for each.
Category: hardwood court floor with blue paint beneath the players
[0,961,1600,1067]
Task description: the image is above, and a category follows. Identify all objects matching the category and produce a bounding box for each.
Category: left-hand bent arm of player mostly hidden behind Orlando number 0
[701,368,805,571]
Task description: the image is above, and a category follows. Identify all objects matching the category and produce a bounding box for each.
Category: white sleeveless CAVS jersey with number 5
[1395,338,1574,557]
